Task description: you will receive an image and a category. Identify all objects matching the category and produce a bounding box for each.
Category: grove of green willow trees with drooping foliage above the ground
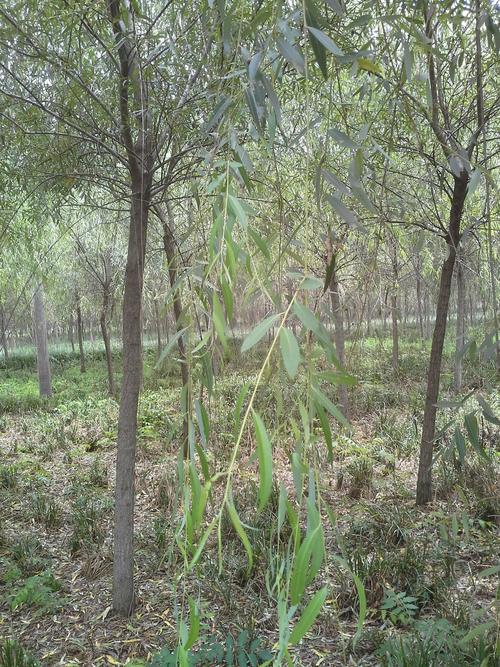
[0,0,500,660]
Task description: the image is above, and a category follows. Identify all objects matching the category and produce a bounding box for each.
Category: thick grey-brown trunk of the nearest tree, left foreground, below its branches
[113,181,149,616]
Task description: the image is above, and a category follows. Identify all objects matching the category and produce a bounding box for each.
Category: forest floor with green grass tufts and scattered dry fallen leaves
[0,340,500,667]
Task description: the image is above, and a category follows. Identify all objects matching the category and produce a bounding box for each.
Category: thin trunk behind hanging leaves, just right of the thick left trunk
[159,201,189,457]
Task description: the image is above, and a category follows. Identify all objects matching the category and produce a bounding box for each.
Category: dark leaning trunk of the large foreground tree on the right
[417,172,469,505]
